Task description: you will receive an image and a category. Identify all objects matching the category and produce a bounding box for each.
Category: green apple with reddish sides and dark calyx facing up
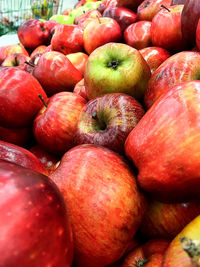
[84,43,151,100]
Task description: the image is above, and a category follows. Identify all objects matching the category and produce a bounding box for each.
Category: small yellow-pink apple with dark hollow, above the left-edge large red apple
[1,53,30,70]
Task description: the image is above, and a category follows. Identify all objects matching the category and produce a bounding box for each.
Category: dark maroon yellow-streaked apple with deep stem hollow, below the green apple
[74,93,144,154]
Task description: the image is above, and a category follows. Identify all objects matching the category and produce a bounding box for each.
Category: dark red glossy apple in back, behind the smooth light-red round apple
[103,7,136,32]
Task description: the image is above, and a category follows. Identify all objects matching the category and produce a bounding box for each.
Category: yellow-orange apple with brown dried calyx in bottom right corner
[162,216,200,267]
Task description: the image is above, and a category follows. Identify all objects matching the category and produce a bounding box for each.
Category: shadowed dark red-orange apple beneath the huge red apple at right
[140,199,200,239]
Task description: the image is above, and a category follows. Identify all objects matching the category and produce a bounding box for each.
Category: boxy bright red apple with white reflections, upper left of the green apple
[51,24,83,55]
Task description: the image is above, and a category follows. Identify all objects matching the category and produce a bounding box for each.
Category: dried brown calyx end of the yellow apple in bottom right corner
[180,236,200,267]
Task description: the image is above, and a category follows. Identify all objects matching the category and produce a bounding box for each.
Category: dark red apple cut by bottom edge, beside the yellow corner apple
[121,239,170,267]
